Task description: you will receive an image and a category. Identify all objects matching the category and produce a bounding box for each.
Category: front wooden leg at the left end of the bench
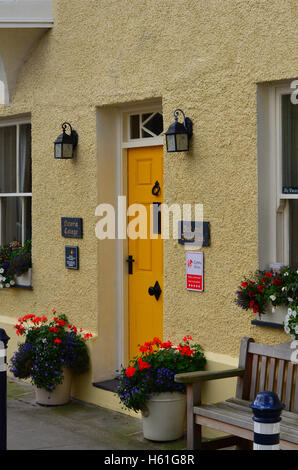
[187,384,202,450]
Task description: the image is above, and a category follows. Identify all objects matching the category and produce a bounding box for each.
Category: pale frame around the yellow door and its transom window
[117,102,164,366]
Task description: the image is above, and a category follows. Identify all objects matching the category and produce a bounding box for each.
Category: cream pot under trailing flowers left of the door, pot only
[35,369,72,406]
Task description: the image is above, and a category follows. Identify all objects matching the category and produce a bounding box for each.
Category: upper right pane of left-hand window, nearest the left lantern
[19,124,32,193]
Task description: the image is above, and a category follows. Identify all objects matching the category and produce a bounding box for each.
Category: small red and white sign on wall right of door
[186,251,204,292]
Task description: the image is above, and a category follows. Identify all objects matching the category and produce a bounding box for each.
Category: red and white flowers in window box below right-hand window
[235,267,298,315]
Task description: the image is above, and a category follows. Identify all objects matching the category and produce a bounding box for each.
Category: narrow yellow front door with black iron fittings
[128,147,163,359]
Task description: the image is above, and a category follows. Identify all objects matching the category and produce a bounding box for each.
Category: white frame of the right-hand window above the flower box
[257,80,298,270]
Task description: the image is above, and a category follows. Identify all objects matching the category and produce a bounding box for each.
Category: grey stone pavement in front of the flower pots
[7,378,186,451]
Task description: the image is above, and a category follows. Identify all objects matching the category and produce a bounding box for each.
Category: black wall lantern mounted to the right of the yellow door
[165,109,192,152]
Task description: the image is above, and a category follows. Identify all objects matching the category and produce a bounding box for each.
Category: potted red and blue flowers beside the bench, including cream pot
[117,335,206,441]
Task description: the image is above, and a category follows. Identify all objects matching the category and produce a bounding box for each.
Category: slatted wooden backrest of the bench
[236,338,298,412]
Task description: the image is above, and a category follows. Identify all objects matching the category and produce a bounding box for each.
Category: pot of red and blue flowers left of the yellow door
[10,309,92,405]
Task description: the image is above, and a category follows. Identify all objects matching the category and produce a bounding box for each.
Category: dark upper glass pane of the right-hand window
[282,95,298,192]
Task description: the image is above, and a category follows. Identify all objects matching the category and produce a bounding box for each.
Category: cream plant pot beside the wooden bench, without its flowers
[142,392,186,441]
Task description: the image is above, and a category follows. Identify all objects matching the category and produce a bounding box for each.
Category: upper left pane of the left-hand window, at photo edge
[0,126,17,193]
